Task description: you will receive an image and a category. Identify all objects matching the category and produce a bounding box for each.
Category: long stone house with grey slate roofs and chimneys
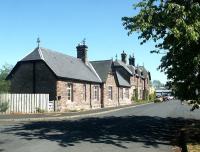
[7,39,149,111]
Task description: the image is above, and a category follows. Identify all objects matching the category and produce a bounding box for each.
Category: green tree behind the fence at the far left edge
[0,64,12,93]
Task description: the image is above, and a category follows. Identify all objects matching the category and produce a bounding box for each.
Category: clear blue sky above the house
[0,0,167,83]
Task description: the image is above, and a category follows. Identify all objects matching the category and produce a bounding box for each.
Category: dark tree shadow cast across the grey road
[1,116,200,148]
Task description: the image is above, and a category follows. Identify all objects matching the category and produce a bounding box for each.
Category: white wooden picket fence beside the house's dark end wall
[0,94,52,114]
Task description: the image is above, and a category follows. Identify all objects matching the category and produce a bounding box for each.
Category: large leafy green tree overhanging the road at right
[122,0,200,107]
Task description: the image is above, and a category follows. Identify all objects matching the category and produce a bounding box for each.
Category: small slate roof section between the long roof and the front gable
[90,60,113,82]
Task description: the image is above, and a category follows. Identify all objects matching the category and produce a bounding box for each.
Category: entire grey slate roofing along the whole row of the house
[7,47,150,87]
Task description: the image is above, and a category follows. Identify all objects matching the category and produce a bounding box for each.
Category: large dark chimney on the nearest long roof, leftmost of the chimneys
[76,40,88,63]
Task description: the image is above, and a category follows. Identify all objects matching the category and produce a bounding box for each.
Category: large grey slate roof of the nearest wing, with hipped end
[20,47,102,83]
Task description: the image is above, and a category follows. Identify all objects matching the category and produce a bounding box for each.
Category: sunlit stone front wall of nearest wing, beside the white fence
[57,81,101,112]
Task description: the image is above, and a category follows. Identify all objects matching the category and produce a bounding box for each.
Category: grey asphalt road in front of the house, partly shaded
[0,101,200,152]
